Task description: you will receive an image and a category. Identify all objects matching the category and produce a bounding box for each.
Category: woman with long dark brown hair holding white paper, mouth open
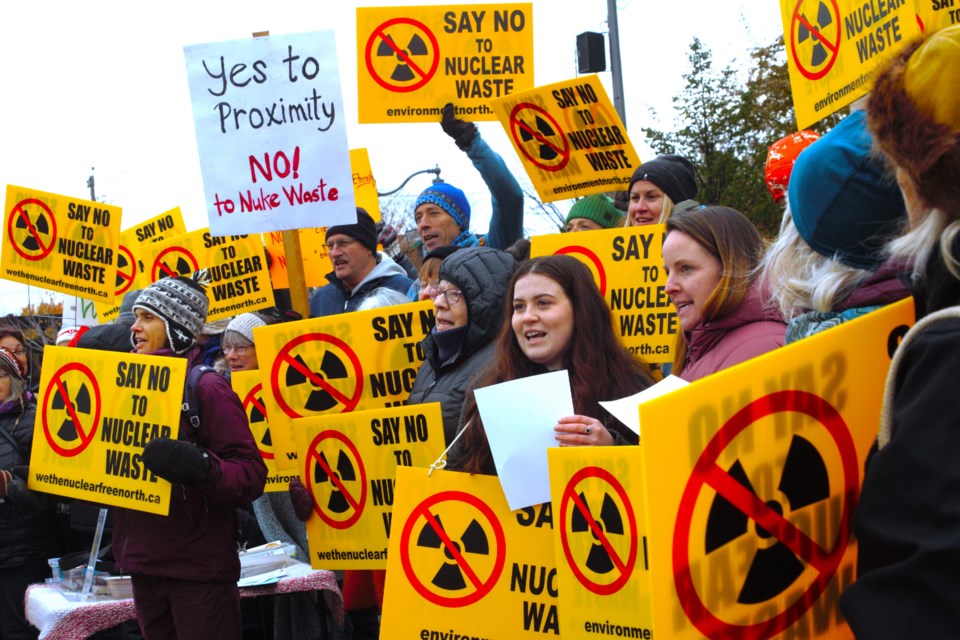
[447,255,653,474]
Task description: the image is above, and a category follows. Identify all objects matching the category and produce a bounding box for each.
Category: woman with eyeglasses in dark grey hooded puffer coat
[407,247,515,443]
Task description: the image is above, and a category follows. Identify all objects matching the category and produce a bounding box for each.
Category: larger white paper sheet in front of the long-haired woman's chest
[474,370,573,511]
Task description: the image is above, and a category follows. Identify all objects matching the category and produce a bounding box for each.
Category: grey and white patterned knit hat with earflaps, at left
[130,269,210,353]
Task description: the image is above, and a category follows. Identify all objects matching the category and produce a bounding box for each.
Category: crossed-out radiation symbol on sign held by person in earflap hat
[41,362,101,457]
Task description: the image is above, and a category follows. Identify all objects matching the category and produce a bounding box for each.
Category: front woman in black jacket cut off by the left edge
[0,347,57,640]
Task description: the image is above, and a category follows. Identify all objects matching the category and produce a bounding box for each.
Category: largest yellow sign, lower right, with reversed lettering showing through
[640,299,913,639]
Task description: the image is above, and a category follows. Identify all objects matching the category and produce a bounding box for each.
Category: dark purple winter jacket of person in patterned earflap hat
[113,347,267,582]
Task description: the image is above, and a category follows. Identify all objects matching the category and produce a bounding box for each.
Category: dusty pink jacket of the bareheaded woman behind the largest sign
[679,283,787,382]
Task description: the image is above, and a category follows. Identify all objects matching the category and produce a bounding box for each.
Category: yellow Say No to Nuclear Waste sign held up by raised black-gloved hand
[357,2,533,124]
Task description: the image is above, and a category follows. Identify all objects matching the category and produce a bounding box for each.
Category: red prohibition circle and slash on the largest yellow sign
[673,390,859,640]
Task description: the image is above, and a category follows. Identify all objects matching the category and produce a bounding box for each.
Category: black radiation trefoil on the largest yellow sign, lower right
[705,435,830,604]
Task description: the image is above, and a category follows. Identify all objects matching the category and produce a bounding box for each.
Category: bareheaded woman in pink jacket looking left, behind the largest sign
[663,207,786,382]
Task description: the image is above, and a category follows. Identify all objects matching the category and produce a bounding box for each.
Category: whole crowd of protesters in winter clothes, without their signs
[0,22,960,640]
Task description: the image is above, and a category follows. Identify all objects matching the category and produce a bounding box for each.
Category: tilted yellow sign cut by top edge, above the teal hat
[780,0,920,129]
